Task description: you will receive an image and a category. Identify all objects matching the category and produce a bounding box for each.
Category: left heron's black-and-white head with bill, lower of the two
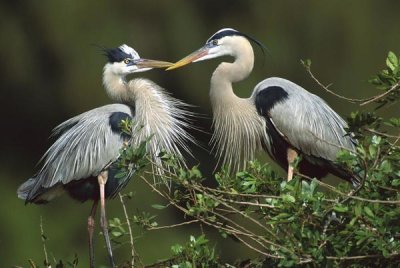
[104,45,172,76]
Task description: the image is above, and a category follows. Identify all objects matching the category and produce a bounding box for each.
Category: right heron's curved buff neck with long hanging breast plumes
[210,40,266,171]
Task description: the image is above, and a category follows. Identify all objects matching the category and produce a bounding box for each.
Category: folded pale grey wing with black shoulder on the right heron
[255,77,354,161]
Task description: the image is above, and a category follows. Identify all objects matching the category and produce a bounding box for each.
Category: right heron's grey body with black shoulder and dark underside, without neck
[251,77,355,182]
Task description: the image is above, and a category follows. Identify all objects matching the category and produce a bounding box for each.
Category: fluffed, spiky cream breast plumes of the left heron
[128,78,193,171]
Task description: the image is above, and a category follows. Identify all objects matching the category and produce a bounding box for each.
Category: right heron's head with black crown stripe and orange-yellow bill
[167,28,252,70]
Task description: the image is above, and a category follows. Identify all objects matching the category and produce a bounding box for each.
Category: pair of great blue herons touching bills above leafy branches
[18,28,359,267]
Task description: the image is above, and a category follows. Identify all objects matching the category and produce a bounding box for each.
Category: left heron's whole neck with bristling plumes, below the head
[103,67,195,174]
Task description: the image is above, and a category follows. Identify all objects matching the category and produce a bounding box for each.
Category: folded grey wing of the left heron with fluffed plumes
[22,104,133,196]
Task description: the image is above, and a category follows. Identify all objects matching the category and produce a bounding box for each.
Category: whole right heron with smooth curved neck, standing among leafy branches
[167,28,359,184]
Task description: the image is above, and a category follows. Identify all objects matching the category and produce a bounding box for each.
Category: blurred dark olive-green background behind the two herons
[0,0,400,267]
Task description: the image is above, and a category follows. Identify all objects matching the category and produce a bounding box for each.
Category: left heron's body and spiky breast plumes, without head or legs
[18,79,189,203]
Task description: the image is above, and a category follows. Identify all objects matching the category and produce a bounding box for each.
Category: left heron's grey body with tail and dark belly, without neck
[18,104,134,203]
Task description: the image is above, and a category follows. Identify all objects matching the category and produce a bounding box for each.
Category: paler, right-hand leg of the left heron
[97,171,116,267]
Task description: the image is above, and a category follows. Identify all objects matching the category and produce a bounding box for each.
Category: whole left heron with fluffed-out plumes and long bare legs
[17,45,192,267]
